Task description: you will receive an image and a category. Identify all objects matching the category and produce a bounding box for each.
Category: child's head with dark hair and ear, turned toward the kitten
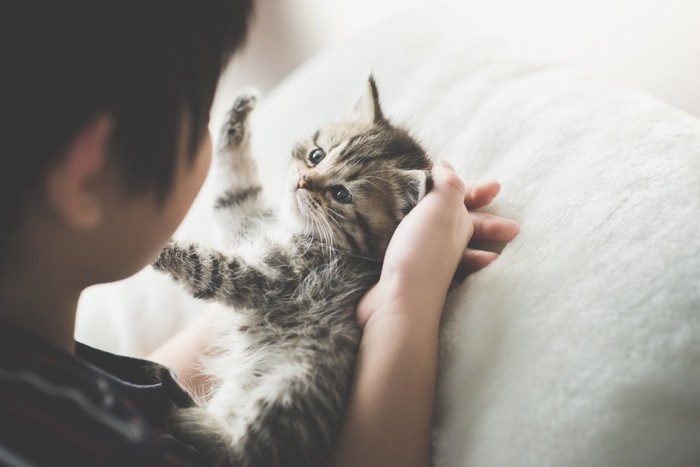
[0,0,252,286]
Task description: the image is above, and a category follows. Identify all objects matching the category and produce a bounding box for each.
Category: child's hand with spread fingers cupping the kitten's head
[357,164,519,326]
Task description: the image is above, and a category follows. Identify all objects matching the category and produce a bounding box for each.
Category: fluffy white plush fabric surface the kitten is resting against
[79,4,700,466]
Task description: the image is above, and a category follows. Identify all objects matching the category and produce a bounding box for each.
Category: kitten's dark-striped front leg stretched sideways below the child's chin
[153,242,290,311]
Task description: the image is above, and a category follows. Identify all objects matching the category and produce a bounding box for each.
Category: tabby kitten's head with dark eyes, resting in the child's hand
[286,77,432,259]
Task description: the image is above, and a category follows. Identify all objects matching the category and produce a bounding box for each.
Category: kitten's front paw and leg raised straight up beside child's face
[214,90,266,239]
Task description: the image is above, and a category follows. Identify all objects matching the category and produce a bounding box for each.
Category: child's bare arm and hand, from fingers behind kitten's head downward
[334,162,518,467]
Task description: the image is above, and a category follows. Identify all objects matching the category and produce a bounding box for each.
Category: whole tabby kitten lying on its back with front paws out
[154,77,432,467]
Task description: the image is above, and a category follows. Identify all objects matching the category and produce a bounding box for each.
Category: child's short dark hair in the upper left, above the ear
[0,0,252,260]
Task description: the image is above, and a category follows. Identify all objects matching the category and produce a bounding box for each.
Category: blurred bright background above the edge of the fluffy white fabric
[214,0,700,117]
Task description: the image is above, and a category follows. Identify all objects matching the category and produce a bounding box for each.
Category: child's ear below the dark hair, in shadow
[46,115,112,229]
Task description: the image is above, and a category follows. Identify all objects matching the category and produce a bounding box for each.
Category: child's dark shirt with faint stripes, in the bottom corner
[0,327,200,467]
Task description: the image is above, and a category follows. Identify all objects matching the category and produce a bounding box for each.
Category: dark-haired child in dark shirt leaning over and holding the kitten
[0,0,518,466]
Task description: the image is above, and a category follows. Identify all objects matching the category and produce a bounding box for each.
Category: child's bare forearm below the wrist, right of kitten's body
[333,301,441,467]
